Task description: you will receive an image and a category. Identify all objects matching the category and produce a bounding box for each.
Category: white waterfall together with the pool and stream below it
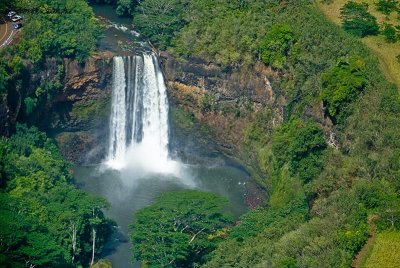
[74,53,249,268]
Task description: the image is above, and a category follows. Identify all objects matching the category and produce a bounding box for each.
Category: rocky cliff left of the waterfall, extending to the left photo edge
[0,52,113,163]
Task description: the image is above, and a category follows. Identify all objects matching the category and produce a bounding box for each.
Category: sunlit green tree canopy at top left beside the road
[9,0,101,63]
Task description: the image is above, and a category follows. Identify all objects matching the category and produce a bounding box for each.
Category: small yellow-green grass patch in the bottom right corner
[364,231,400,268]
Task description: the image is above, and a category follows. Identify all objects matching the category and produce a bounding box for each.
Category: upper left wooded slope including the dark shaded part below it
[0,0,101,134]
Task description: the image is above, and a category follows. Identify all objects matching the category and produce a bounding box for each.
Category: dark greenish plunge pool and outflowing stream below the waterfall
[74,158,249,268]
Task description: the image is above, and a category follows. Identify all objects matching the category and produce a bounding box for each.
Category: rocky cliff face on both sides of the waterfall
[0,45,285,168]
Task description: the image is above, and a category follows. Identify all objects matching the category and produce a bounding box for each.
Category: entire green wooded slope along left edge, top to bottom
[0,0,113,267]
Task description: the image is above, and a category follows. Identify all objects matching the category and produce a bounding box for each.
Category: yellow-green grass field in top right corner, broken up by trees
[318,0,400,89]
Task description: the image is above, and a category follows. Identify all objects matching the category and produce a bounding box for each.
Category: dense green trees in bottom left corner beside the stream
[0,125,110,267]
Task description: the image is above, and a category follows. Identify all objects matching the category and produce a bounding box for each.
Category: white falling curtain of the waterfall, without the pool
[107,54,169,169]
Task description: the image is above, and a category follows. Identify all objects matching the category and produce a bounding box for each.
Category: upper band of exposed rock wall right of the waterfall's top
[160,52,275,105]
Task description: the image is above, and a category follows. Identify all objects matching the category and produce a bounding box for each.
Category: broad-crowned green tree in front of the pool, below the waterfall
[131,191,232,267]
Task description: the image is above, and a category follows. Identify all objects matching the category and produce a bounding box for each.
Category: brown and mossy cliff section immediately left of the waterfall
[47,52,113,164]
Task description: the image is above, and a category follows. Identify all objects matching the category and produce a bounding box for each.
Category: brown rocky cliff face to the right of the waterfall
[160,52,285,156]
